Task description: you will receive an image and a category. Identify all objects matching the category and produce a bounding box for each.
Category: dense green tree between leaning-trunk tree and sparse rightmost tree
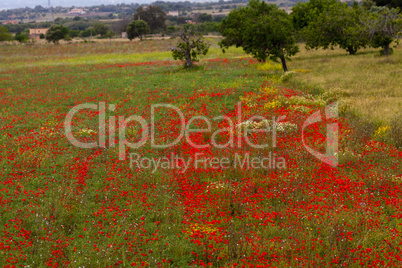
[303,2,369,55]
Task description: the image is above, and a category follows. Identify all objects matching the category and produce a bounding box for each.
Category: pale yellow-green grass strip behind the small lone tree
[0,37,246,70]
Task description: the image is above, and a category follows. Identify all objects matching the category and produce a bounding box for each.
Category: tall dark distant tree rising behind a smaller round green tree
[134,6,167,33]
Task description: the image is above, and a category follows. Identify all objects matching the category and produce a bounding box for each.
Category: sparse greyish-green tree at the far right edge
[366,7,402,56]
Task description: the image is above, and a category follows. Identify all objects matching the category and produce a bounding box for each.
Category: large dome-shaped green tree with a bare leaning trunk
[220,0,299,72]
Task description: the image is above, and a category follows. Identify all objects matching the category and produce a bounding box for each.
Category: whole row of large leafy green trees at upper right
[220,0,402,72]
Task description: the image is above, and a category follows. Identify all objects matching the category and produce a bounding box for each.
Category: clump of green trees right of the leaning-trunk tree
[291,0,402,55]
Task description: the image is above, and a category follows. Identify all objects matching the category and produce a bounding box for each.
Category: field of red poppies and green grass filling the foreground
[0,41,402,267]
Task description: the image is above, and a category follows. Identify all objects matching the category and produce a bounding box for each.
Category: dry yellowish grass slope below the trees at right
[289,45,402,124]
